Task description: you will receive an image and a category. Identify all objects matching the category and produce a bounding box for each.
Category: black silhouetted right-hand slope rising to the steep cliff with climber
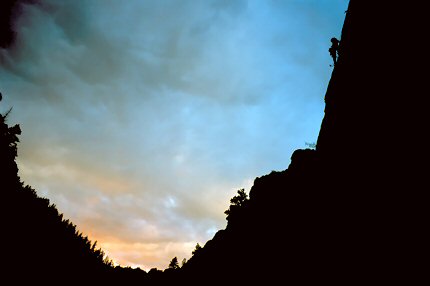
[184,0,425,285]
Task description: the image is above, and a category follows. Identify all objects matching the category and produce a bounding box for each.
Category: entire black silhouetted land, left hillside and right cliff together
[0,0,428,285]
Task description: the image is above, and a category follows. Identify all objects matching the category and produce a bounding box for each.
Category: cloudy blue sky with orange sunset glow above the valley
[0,0,348,270]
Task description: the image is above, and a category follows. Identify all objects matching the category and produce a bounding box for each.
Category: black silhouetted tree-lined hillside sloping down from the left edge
[0,94,172,285]
